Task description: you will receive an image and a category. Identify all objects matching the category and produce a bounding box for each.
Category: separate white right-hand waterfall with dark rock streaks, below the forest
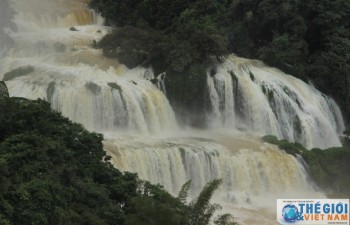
[208,55,344,148]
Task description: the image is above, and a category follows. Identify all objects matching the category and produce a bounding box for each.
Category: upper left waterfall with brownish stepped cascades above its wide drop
[0,0,177,133]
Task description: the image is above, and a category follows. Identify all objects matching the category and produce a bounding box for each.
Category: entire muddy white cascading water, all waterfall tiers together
[0,0,343,225]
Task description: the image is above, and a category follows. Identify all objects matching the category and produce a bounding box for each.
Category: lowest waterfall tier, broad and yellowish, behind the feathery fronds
[104,131,324,225]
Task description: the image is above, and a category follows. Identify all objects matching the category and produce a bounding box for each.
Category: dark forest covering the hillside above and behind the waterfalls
[90,0,350,123]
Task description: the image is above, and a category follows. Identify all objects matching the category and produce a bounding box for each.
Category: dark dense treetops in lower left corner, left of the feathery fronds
[0,98,138,225]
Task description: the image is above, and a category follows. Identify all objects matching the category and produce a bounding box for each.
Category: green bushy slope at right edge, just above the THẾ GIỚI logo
[262,135,350,197]
